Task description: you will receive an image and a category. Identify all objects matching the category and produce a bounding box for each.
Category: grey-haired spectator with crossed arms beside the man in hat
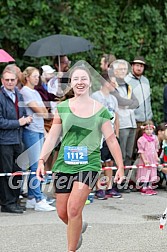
[112,60,138,165]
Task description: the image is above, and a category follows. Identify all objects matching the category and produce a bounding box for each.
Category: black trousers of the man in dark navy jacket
[0,144,23,206]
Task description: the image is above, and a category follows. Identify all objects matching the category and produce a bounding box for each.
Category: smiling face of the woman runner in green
[71,69,91,96]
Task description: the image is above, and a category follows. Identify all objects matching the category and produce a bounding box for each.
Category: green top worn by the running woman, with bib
[52,100,111,174]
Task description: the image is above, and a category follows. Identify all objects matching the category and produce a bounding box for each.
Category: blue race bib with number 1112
[64,146,88,165]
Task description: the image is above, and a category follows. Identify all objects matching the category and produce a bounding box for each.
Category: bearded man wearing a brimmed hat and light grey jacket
[125,56,153,159]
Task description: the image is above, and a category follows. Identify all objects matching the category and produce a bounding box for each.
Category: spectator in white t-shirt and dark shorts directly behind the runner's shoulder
[91,72,121,200]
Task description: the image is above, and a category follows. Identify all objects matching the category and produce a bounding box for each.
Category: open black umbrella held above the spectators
[24,34,93,58]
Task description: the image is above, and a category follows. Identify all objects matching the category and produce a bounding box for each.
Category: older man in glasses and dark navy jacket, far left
[0,68,32,213]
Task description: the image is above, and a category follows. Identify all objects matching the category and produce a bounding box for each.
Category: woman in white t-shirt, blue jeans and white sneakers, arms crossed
[20,67,55,211]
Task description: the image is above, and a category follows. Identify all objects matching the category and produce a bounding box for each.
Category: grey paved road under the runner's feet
[0,190,167,252]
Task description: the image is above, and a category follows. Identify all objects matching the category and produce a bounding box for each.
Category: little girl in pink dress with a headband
[136,121,159,195]
